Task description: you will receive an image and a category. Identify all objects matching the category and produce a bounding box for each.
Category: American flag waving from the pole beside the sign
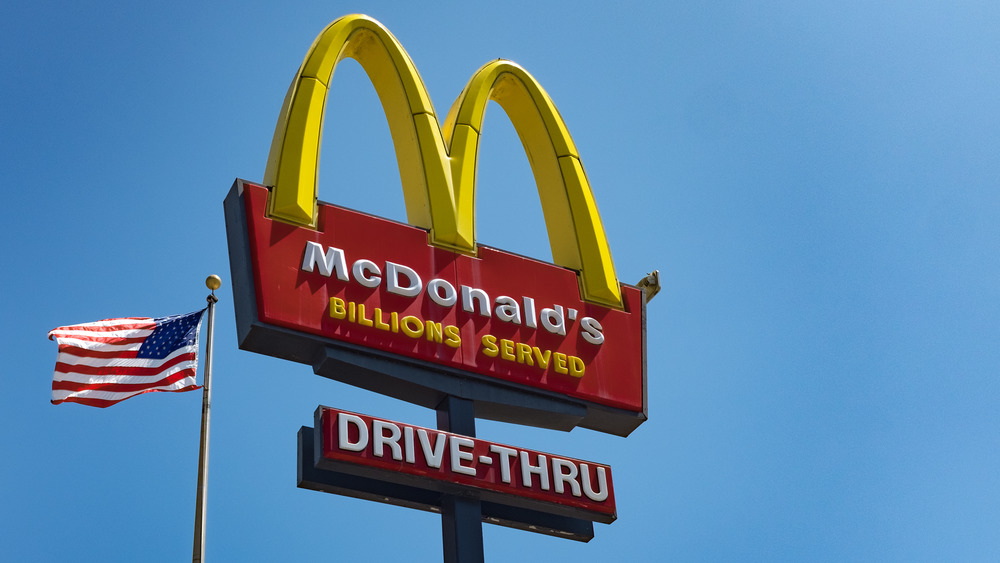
[49,309,205,407]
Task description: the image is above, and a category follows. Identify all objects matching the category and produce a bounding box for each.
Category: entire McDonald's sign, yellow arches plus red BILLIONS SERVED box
[225,12,646,435]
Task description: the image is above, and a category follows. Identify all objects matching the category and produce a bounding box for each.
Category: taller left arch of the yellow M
[264,15,464,251]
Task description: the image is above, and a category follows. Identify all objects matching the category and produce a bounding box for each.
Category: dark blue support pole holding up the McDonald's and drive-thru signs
[437,395,485,563]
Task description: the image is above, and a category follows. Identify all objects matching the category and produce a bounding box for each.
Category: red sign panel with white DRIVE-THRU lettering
[316,407,617,523]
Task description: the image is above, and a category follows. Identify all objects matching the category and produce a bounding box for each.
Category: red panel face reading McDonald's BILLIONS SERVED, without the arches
[243,183,645,418]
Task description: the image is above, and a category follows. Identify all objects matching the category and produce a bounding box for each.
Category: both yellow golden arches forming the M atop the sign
[264,15,622,307]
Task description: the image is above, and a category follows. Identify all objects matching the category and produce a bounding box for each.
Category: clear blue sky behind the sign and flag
[0,0,1000,562]
